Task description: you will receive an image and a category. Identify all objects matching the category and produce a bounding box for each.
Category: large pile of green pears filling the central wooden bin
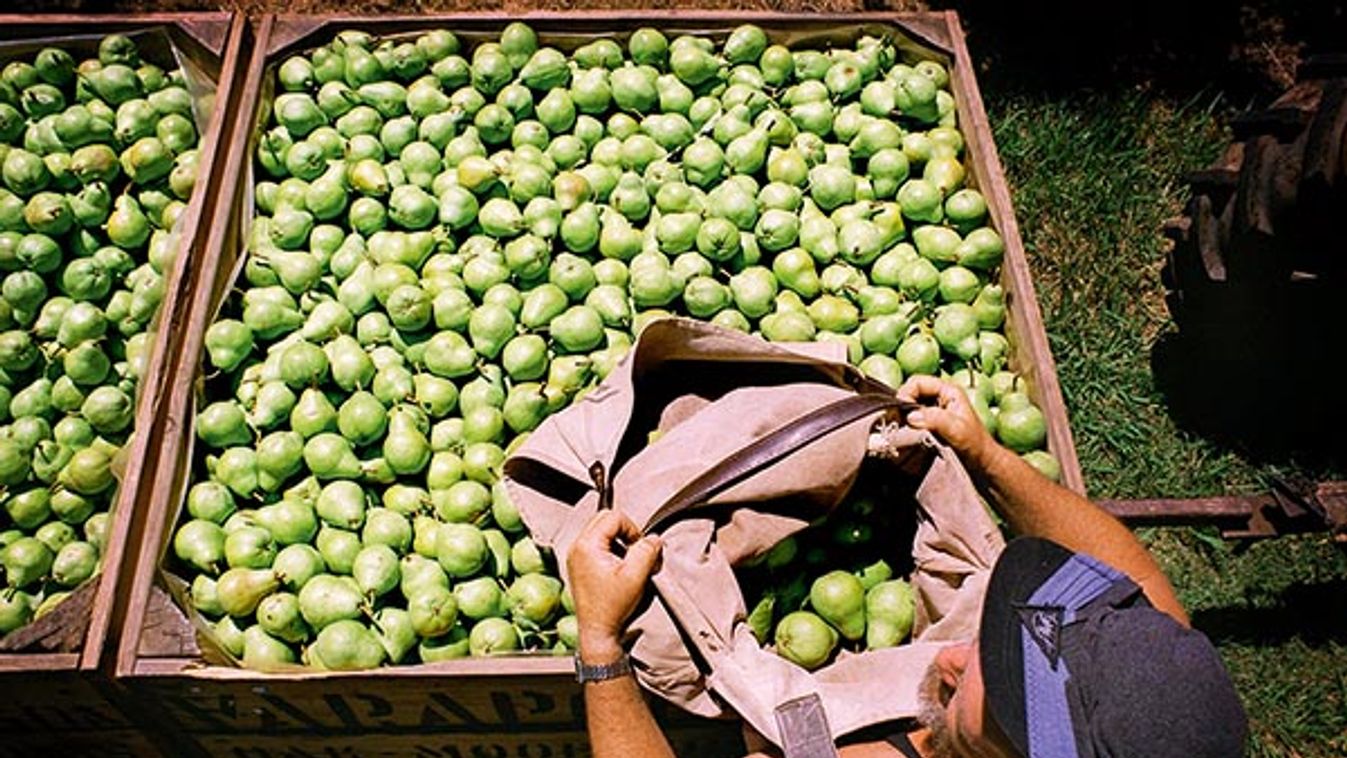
[172,23,1051,669]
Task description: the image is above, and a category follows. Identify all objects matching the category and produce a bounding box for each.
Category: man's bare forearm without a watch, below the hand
[975,444,1188,623]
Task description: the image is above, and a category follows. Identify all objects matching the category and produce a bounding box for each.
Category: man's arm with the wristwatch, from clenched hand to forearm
[566,510,674,758]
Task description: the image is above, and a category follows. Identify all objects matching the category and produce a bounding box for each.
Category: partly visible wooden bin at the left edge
[0,12,247,755]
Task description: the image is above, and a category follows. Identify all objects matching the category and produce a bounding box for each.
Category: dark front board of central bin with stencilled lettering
[136,670,742,757]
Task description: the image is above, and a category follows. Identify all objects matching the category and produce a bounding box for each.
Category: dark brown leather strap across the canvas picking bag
[644,392,902,533]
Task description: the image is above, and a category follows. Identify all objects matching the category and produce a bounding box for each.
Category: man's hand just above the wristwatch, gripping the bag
[566,510,661,664]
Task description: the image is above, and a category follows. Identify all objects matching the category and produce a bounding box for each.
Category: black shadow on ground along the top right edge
[932,0,1347,102]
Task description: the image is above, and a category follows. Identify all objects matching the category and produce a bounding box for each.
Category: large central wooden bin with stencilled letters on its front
[116,11,1083,757]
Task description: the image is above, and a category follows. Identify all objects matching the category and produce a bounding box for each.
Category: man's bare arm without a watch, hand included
[898,376,1188,626]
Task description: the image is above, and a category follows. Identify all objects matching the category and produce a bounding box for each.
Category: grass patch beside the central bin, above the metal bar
[991,90,1258,497]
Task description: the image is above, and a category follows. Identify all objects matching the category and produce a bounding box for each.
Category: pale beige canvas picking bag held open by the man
[505,319,1004,755]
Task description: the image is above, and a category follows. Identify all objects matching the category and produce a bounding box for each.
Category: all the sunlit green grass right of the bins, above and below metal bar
[987,88,1347,757]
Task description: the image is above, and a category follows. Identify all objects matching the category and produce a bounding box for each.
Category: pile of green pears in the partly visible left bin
[0,35,197,635]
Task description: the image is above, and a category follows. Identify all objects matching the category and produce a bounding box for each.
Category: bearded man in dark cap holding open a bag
[567,377,1247,758]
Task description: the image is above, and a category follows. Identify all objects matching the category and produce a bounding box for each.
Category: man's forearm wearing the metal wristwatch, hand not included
[581,640,674,758]
